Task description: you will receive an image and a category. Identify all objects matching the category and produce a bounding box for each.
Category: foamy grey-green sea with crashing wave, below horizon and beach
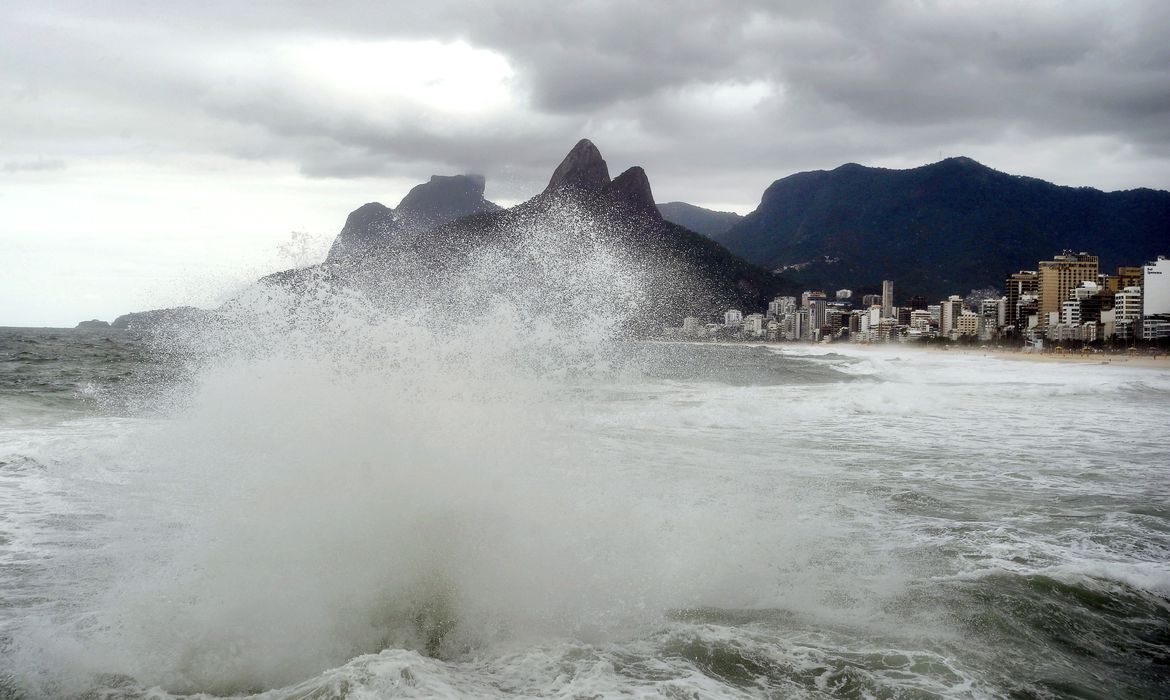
[0,316,1170,700]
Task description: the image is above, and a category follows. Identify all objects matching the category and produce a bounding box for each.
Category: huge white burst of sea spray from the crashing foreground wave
[6,204,814,693]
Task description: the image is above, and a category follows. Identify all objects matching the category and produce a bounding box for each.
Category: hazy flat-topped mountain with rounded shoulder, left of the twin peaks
[326,174,500,261]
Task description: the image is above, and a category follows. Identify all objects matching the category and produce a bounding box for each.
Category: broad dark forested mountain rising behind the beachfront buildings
[720,158,1170,298]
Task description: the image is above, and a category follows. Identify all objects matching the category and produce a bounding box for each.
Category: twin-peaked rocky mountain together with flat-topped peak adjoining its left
[262,139,777,331]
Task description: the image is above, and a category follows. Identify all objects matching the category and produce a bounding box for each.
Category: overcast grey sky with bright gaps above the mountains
[0,0,1170,325]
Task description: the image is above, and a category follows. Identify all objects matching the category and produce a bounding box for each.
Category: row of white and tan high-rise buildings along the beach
[669,251,1170,345]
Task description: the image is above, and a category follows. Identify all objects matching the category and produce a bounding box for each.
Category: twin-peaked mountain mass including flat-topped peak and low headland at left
[113,139,796,335]
